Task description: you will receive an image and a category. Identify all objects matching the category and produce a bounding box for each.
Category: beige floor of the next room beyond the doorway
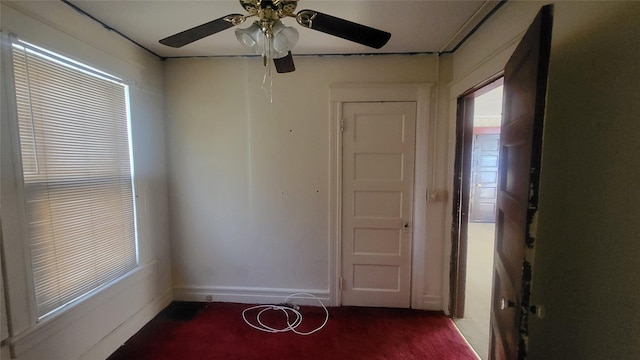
[455,223,495,360]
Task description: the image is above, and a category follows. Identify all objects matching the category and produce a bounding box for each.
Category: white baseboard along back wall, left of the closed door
[173,286,331,306]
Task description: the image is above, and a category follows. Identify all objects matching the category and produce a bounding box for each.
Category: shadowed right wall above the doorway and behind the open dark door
[447,1,640,359]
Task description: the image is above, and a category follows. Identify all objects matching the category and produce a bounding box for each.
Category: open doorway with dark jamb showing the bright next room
[451,78,503,359]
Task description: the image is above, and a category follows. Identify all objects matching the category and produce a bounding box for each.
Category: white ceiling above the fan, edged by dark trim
[67,0,500,57]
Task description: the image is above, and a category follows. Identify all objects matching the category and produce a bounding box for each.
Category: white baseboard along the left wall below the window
[79,288,173,360]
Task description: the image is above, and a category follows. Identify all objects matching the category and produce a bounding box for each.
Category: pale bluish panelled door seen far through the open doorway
[469,134,500,222]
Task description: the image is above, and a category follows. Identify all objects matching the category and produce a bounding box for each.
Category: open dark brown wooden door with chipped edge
[489,5,553,359]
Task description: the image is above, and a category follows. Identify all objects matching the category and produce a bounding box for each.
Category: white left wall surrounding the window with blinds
[1,1,172,360]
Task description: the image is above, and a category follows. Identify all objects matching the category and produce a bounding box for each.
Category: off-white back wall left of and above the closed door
[165,56,442,302]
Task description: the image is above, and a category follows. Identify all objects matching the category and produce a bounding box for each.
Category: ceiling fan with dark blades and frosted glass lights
[160,0,391,73]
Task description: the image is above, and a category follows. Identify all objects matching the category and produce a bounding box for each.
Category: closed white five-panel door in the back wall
[341,102,416,308]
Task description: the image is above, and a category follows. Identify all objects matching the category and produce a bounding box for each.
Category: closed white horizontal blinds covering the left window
[13,43,137,318]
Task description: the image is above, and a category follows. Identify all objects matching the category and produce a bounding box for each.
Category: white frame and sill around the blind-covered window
[0,33,141,330]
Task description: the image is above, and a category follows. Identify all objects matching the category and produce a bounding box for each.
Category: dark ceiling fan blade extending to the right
[296,10,391,49]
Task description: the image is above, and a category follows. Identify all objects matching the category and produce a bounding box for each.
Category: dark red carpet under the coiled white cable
[108,303,477,360]
